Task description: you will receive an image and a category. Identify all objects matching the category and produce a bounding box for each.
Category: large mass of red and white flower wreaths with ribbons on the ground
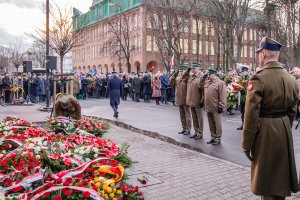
[0,118,144,200]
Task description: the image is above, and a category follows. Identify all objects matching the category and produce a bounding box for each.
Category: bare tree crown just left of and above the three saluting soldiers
[145,0,191,71]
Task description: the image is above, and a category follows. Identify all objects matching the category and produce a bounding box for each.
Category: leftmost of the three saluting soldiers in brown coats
[170,66,191,135]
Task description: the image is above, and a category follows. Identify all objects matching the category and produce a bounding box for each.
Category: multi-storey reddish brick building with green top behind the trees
[72,0,259,73]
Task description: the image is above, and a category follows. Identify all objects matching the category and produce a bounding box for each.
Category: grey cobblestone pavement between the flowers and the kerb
[105,127,300,200]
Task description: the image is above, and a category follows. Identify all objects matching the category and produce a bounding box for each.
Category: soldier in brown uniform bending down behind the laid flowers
[54,94,81,119]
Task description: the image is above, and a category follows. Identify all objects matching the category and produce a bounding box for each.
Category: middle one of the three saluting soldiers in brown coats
[186,63,204,140]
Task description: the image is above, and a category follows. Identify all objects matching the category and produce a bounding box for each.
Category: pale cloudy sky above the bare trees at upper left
[0,0,92,46]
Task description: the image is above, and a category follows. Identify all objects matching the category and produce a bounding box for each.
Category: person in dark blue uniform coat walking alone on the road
[107,71,122,118]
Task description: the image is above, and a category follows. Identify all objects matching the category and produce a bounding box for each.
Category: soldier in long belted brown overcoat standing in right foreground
[242,37,299,200]
